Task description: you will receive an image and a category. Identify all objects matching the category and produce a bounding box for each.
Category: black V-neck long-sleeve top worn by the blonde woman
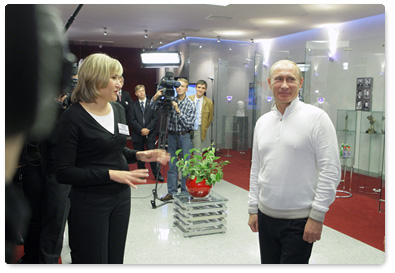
[55,102,137,193]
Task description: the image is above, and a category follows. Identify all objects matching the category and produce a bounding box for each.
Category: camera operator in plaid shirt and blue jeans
[151,78,196,201]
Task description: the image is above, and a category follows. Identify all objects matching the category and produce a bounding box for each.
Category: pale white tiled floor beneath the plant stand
[62,181,385,264]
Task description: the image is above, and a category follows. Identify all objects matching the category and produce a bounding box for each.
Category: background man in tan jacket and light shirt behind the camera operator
[189,80,214,151]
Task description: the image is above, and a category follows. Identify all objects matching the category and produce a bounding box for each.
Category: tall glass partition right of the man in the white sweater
[304,35,385,202]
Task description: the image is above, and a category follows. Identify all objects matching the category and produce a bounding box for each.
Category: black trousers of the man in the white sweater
[258,211,313,264]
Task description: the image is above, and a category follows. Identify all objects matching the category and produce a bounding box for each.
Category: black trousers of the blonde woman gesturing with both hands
[69,187,130,264]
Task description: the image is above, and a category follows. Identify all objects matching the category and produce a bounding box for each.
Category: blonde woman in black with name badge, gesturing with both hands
[56,53,170,264]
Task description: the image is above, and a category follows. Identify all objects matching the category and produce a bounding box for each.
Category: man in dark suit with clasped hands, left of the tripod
[130,84,164,182]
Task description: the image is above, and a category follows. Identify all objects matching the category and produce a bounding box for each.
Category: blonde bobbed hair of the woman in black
[71,53,123,103]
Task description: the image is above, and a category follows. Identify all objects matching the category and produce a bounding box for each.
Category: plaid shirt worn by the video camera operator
[151,96,196,132]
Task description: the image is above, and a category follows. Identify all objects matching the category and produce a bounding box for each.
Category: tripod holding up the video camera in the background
[151,101,172,209]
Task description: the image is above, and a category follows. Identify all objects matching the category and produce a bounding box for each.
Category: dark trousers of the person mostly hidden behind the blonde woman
[40,174,71,264]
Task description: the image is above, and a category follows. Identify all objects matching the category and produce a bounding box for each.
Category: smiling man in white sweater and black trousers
[248,60,341,264]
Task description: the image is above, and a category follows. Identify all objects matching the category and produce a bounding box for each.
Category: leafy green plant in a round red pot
[171,143,230,197]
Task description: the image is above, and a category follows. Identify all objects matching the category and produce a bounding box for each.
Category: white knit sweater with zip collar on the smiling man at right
[248,98,341,222]
